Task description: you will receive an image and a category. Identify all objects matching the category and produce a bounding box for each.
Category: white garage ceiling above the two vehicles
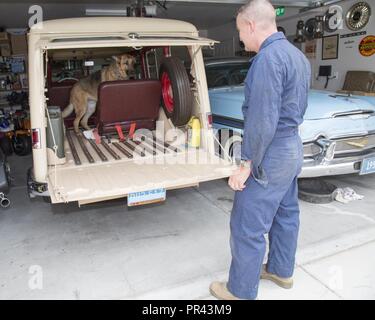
[0,0,334,29]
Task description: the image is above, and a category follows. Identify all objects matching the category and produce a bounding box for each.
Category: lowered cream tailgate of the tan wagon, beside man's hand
[48,150,235,204]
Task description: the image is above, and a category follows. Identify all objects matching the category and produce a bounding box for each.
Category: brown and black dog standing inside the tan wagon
[62,54,135,133]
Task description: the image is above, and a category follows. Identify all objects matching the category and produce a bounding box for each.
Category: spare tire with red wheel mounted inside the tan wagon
[159,57,193,126]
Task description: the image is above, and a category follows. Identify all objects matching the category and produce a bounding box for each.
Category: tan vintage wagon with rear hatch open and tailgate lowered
[28,17,235,205]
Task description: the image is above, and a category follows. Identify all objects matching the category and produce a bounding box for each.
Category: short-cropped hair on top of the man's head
[238,0,276,28]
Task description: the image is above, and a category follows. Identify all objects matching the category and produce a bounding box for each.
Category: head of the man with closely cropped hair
[237,0,277,52]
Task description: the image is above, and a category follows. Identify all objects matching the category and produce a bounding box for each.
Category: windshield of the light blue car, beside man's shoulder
[206,61,250,88]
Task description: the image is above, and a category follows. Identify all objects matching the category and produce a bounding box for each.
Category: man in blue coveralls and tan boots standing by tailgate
[210,0,311,300]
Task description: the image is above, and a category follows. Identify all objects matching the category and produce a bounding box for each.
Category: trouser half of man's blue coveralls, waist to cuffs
[227,136,303,299]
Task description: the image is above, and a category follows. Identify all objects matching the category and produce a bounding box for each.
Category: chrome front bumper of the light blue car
[299,152,375,178]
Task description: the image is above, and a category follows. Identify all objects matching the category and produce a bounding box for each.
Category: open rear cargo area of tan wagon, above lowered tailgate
[45,47,216,167]
